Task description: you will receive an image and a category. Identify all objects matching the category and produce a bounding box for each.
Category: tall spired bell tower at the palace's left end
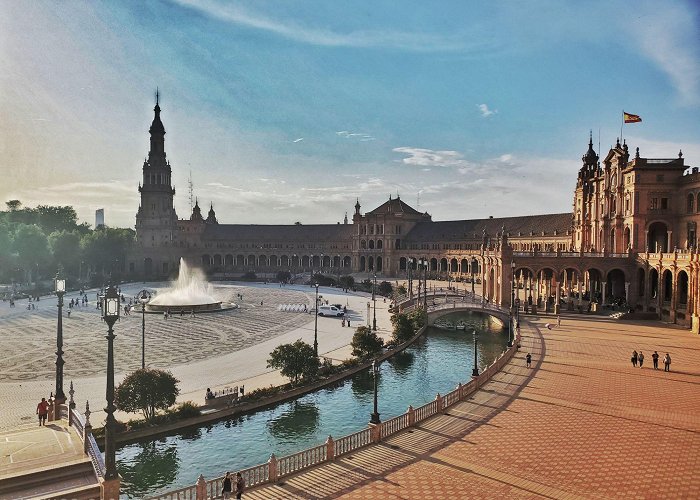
[136,90,177,250]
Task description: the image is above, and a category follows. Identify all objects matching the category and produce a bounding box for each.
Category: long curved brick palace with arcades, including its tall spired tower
[127,100,700,332]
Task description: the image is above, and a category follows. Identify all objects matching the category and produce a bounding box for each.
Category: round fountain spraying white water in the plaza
[146,258,233,313]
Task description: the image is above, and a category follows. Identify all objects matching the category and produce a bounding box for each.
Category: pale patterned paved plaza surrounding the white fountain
[0,283,390,430]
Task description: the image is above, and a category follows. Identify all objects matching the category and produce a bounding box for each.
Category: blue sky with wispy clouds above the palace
[0,0,700,227]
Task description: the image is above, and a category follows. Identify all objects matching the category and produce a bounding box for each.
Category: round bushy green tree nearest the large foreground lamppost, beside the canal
[114,368,180,421]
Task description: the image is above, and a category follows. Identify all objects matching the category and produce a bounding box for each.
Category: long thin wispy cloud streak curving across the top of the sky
[176,0,489,53]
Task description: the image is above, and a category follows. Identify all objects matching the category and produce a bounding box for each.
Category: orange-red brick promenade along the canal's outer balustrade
[246,316,700,499]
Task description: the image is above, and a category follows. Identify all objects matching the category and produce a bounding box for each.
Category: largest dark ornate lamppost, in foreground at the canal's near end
[102,285,120,484]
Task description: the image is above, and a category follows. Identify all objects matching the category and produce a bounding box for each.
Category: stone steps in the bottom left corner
[0,457,100,500]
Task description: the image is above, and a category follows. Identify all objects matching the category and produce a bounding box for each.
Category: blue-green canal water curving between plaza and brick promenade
[117,313,508,498]
